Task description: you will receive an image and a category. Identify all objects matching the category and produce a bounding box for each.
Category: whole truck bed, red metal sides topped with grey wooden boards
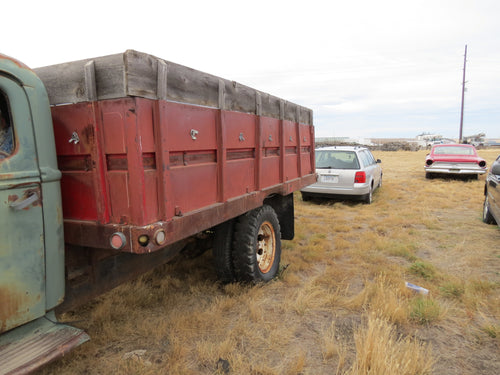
[35,51,315,253]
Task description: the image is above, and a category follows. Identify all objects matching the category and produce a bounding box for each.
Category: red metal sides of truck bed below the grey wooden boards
[53,97,314,253]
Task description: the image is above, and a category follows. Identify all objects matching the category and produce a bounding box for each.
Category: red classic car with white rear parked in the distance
[424,144,487,178]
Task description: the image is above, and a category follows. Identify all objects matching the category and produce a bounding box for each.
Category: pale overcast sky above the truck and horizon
[4,0,500,138]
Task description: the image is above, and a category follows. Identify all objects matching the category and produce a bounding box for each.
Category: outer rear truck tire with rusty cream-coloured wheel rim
[233,205,281,282]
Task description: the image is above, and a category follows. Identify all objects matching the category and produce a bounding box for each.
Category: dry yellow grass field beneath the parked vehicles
[39,149,500,375]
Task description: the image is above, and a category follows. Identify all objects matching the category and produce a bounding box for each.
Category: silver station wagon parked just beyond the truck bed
[301,146,382,203]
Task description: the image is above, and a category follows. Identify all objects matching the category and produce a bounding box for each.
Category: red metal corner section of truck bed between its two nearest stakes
[99,98,159,225]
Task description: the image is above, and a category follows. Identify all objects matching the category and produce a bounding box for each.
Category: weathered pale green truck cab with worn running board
[0,55,88,374]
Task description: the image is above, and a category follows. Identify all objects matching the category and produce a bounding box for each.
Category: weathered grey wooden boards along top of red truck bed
[34,50,313,125]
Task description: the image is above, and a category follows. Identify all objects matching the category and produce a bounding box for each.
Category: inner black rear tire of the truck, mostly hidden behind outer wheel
[213,220,235,283]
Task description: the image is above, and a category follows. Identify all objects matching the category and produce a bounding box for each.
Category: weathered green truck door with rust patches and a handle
[0,74,45,333]
